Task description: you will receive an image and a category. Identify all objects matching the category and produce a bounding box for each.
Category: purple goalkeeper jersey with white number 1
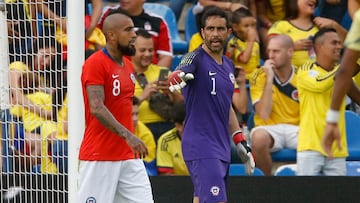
[177,47,235,162]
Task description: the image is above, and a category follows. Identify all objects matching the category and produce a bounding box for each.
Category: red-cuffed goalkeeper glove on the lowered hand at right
[232,130,255,175]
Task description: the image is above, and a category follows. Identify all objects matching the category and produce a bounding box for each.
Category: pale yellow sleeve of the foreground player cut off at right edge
[345,9,360,51]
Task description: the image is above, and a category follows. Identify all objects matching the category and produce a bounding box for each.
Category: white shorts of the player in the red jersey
[78,159,154,203]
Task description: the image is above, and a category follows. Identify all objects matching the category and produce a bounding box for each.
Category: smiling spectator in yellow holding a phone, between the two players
[132,29,183,142]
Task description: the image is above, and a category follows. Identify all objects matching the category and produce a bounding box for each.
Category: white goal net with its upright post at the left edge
[0,0,84,203]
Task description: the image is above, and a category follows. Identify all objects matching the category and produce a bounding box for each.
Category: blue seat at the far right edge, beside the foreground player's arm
[345,111,360,161]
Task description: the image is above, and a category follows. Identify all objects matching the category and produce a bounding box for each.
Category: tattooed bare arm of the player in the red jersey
[86,85,132,139]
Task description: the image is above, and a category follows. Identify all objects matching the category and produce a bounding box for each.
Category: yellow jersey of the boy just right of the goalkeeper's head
[227,37,260,80]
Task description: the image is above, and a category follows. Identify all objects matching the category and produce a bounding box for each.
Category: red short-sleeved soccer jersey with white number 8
[79,49,135,161]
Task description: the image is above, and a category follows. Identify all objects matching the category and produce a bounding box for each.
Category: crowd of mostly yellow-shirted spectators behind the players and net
[2,0,360,179]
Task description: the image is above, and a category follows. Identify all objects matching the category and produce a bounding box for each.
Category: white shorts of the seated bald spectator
[250,124,299,152]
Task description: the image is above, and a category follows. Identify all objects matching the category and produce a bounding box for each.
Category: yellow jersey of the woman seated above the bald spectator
[268,20,319,67]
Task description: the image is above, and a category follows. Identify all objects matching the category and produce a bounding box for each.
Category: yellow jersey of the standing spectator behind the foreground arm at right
[297,63,348,157]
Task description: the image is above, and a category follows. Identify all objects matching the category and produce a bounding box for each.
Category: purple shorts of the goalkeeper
[185,159,229,203]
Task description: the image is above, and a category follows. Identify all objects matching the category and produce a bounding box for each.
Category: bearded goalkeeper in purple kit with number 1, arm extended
[169,7,255,203]
